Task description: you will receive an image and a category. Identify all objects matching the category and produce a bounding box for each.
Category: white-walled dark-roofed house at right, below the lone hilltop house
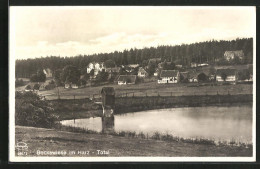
[216,69,237,82]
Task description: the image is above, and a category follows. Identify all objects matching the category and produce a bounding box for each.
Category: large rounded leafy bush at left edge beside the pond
[15,92,58,128]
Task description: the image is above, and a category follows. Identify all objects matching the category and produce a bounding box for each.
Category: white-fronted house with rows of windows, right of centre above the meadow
[158,70,180,84]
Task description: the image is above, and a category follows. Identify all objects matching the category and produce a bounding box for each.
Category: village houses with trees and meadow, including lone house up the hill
[16,50,253,99]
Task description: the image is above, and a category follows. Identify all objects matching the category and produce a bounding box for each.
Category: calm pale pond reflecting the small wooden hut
[61,105,253,143]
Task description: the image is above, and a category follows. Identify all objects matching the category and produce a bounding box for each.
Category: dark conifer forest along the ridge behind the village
[15,38,253,78]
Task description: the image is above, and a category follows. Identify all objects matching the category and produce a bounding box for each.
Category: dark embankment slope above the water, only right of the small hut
[116,94,253,114]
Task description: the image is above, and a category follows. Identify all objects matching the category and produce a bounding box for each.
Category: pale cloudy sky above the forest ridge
[9,6,256,59]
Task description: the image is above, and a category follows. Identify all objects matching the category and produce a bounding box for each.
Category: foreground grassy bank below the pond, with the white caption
[15,126,252,157]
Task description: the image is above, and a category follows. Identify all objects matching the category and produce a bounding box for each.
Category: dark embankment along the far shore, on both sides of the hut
[49,94,253,119]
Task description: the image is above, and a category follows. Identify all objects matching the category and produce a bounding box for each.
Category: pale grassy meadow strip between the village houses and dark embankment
[36,81,253,100]
